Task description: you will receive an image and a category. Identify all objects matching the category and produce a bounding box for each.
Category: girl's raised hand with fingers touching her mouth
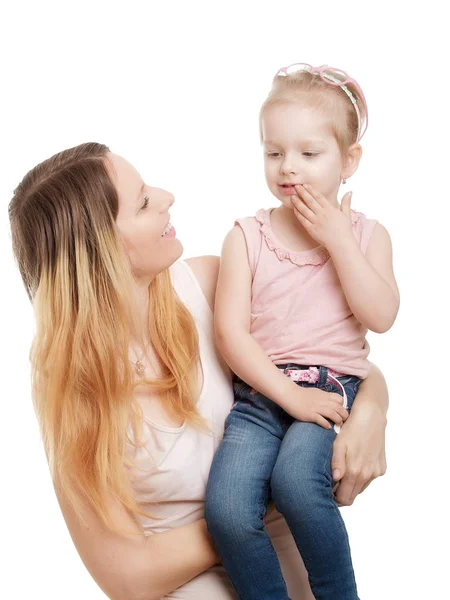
[291,183,354,249]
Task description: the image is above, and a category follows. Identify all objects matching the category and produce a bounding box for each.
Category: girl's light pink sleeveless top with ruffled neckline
[236,209,377,379]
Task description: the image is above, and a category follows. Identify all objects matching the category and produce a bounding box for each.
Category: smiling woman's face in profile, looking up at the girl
[107,153,183,279]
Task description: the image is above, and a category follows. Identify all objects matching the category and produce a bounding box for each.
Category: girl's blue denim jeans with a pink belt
[205,365,360,600]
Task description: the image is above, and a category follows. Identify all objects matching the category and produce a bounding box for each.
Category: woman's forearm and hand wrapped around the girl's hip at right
[331,364,389,506]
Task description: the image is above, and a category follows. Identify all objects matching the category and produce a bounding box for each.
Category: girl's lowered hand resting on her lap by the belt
[283,386,348,429]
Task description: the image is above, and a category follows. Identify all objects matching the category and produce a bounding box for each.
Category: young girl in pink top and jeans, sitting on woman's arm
[206,64,399,600]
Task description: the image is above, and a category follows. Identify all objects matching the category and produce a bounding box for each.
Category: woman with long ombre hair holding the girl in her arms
[9,143,387,600]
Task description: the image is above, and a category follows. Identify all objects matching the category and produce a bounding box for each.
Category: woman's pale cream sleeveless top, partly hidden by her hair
[125,260,314,600]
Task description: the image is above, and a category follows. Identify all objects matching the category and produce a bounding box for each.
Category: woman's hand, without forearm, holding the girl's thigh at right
[331,404,386,506]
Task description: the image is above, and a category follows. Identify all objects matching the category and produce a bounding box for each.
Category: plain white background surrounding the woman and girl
[0,0,450,600]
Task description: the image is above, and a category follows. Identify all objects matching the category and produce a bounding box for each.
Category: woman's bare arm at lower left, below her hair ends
[55,487,220,600]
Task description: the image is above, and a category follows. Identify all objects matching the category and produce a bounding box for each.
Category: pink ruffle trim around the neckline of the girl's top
[255,208,361,266]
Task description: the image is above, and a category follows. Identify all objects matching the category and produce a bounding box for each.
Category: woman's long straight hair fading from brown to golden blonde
[9,143,206,530]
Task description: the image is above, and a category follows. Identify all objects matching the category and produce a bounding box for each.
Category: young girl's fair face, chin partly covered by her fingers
[262,102,350,208]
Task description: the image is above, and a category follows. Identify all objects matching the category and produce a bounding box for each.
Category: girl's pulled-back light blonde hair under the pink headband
[259,71,367,156]
